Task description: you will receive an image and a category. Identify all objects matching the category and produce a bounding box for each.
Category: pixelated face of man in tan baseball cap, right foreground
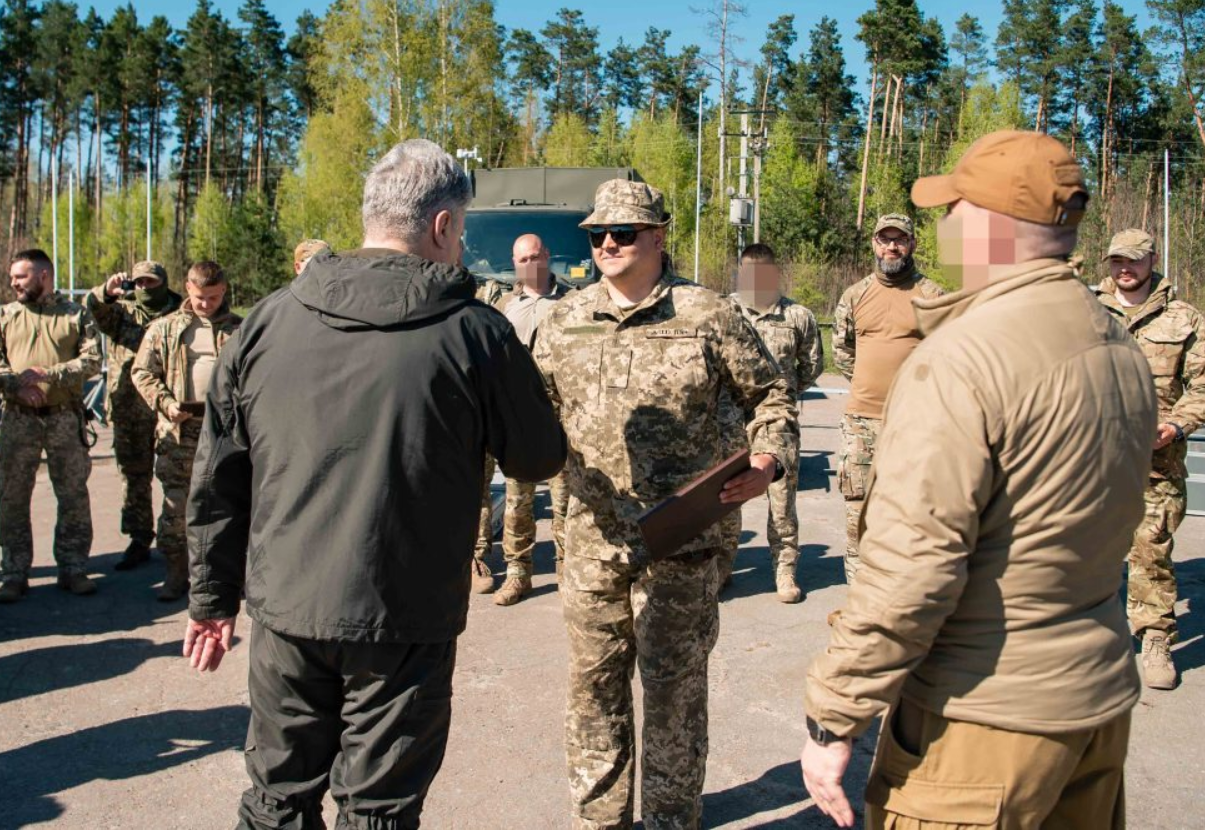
[937,199,1017,290]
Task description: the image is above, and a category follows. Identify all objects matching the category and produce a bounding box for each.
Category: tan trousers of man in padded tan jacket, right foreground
[866,701,1130,830]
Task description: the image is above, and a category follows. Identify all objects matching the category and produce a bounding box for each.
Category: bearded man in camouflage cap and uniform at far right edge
[1097,229,1205,689]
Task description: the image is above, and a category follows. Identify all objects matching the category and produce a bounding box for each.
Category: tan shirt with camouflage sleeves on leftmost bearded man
[0,294,100,406]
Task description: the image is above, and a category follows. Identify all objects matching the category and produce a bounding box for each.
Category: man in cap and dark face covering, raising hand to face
[87,261,181,571]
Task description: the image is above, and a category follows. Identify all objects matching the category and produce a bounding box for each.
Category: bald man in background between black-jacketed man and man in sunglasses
[494,234,569,605]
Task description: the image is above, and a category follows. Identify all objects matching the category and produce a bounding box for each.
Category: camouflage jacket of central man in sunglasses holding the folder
[534,272,798,563]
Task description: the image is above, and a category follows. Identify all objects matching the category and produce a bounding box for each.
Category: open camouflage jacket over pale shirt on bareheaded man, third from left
[131,300,242,435]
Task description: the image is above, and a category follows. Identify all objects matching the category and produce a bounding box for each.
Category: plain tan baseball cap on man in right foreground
[912,130,1088,226]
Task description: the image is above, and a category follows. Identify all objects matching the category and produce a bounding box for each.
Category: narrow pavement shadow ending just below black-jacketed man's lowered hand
[0,637,181,704]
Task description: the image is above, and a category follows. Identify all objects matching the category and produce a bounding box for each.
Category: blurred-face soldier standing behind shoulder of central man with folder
[721,242,824,602]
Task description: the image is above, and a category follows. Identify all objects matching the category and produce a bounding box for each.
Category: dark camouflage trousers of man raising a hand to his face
[110,396,158,546]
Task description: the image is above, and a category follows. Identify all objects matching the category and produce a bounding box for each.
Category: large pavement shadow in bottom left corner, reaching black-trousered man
[0,706,251,828]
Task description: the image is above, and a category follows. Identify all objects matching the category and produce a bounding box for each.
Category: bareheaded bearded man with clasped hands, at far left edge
[0,249,100,602]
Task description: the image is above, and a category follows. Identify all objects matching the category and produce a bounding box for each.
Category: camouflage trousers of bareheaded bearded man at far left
[0,406,92,581]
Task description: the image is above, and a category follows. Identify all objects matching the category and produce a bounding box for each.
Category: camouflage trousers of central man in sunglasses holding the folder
[560,553,719,830]
